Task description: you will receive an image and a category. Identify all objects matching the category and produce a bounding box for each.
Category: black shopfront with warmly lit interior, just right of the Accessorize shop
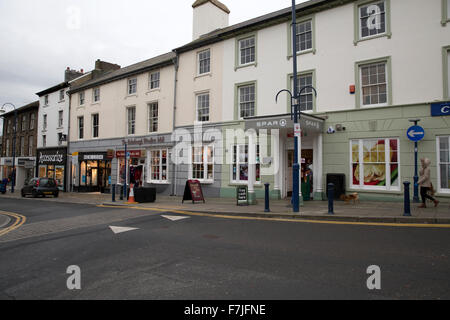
[76,152,111,193]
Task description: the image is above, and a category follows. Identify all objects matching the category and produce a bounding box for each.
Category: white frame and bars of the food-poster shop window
[348,137,402,192]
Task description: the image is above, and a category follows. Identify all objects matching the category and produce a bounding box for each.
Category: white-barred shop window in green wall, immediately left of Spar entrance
[231,144,261,183]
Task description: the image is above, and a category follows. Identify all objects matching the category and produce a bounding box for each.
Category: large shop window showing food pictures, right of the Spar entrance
[350,138,400,191]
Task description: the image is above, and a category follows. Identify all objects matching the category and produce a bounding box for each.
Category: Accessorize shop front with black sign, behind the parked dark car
[36,148,67,191]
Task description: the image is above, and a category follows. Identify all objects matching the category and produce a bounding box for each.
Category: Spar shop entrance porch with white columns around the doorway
[245,113,325,200]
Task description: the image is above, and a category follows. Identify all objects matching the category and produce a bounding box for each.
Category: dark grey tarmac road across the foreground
[0,199,450,300]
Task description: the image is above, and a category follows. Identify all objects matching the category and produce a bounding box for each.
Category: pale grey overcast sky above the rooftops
[0,0,305,134]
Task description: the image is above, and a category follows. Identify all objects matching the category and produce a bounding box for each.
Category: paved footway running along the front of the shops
[0,191,450,225]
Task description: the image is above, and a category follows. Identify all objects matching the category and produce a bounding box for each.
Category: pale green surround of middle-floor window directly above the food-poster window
[355,56,393,109]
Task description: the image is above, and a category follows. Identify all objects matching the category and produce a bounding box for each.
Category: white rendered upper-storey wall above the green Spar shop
[223,0,450,120]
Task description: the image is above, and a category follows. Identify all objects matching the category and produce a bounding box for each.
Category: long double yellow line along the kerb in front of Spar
[99,205,450,228]
